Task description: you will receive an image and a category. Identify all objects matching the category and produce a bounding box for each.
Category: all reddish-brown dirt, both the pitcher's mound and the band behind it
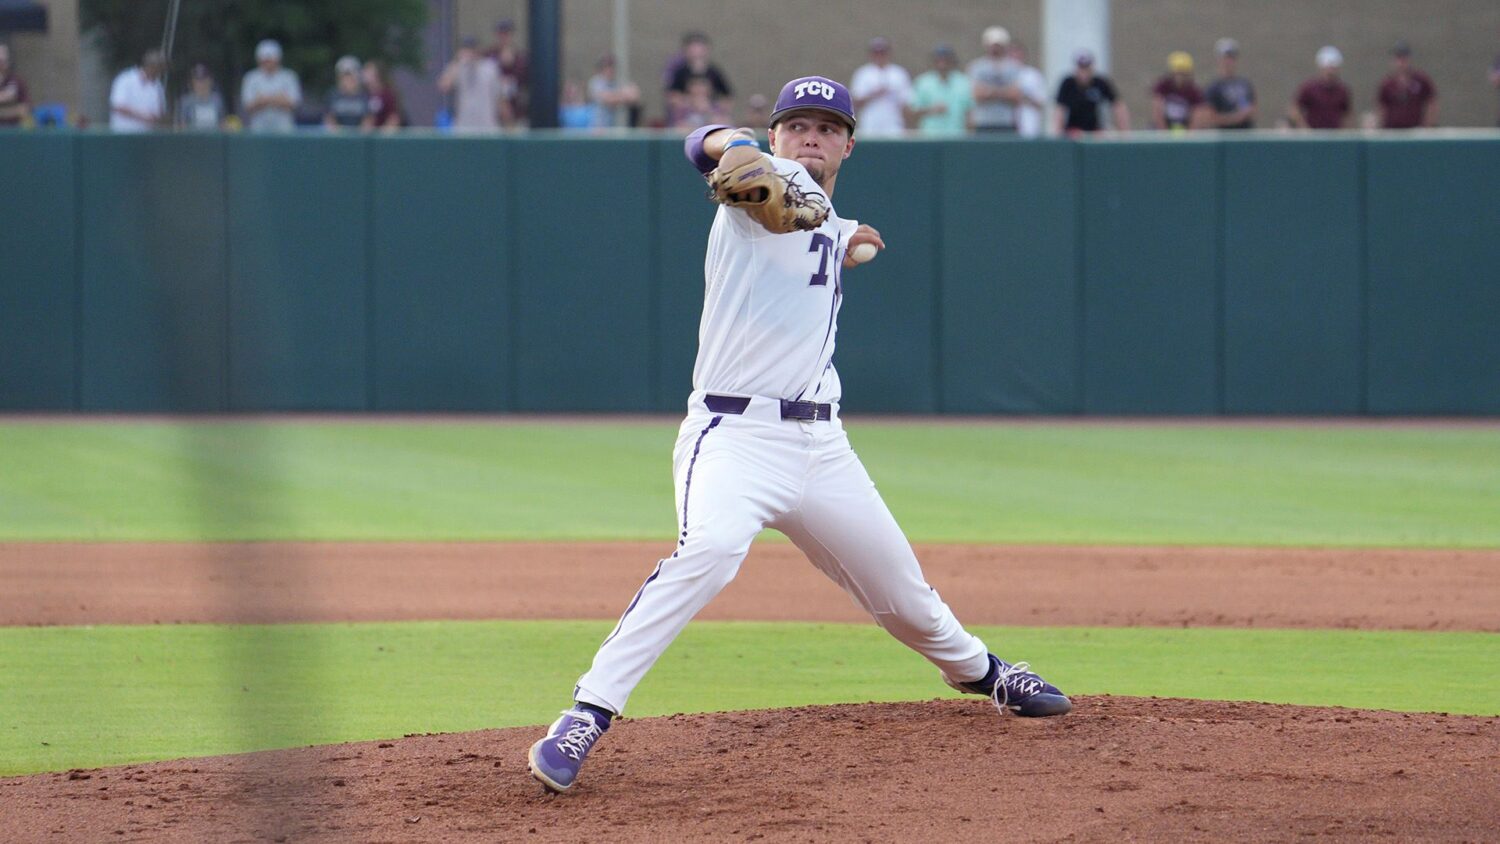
[0,543,1500,843]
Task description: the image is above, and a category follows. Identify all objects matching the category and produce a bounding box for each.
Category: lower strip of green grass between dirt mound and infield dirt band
[0,621,1500,775]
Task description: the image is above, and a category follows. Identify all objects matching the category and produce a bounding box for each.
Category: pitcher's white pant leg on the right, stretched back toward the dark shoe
[773,447,990,682]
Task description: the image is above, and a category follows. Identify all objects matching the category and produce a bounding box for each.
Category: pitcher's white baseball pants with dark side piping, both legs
[575,393,990,712]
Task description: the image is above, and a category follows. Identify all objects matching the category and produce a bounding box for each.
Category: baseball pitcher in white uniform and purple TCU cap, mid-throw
[528,76,1073,792]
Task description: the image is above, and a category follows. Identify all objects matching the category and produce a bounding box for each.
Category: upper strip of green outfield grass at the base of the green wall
[0,418,1500,547]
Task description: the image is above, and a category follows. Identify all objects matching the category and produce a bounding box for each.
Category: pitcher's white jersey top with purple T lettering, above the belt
[693,157,860,402]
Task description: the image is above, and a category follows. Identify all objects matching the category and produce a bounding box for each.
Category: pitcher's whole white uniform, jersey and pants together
[573,138,990,712]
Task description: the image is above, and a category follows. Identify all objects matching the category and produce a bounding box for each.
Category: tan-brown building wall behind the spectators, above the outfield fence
[456,0,1500,126]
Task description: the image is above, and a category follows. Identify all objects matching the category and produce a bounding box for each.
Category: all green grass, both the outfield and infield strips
[0,420,1500,775]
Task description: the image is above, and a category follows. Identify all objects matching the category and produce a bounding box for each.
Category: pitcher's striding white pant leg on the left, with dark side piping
[573,426,786,714]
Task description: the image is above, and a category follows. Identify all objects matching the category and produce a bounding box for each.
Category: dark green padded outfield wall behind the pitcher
[0,133,1500,415]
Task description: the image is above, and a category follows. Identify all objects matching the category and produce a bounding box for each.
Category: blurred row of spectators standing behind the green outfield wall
[0,19,1500,138]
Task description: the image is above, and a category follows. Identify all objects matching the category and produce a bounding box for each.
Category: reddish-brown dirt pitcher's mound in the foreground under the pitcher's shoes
[0,697,1500,841]
